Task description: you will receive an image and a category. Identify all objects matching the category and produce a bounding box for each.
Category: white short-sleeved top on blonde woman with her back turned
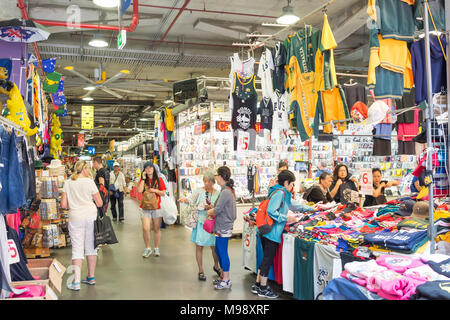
[63,178,98,221]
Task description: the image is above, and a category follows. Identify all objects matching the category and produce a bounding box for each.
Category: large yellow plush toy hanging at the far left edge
[0,76,38,136]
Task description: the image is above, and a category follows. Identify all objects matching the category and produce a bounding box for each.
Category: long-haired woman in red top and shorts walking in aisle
[138,162,166,258]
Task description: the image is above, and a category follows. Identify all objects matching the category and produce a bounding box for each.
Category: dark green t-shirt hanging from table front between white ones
[294,238,314,300]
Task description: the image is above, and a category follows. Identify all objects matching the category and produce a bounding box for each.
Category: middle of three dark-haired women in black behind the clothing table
[330,163,359,203]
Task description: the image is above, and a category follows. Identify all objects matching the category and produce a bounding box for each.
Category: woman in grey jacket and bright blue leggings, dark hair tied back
[207,166,236,290]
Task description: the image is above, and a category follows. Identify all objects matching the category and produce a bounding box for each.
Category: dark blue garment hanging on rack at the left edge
[0,128,26,214]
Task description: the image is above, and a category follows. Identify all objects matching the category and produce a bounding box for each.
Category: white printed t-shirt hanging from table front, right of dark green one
[314,244,341,300]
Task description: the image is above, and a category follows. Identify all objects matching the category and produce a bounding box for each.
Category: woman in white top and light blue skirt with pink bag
[179,172,220,281]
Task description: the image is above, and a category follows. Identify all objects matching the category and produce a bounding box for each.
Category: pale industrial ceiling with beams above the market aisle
[0,0,368,149]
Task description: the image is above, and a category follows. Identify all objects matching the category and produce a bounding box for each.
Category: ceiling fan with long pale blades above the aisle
[64,65,156,100]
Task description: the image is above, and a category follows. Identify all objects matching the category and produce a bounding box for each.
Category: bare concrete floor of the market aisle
[52,198,292,300]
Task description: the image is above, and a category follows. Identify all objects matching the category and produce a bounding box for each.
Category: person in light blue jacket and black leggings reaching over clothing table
[252,170,314,299]
